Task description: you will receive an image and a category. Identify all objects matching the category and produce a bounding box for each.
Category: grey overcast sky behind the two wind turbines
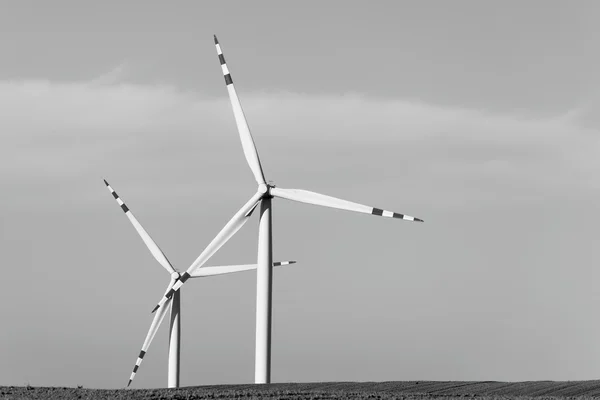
[0,0,600,388]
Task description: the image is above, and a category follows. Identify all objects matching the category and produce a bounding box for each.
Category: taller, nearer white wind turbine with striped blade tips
[148,36,423,383]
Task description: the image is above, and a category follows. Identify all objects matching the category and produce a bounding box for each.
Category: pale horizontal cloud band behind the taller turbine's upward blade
[0,76,598,211]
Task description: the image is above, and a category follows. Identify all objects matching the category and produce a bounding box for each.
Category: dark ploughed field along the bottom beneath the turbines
[0,381,600,400]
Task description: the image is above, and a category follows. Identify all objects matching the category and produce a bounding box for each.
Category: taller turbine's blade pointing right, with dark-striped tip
[271,187,423,222]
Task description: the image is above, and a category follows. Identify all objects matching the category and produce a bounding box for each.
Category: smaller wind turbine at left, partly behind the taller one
[104,180,296,388]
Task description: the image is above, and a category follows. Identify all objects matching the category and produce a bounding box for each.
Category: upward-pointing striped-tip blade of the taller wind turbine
[215,35,265,185]
